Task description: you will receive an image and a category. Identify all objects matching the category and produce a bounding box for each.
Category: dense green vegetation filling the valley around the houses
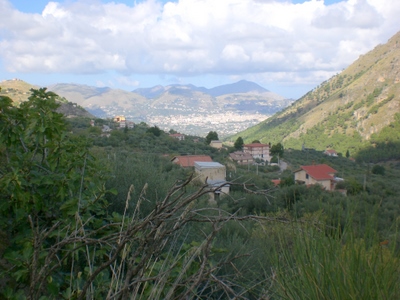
[0,89,400,299]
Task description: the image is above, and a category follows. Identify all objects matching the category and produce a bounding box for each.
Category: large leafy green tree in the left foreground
[0,88,107,299]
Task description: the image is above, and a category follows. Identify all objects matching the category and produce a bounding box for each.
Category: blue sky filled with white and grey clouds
[0,0,400,99]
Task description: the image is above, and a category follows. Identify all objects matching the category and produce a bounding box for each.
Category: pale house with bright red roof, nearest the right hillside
[294,164,337,191]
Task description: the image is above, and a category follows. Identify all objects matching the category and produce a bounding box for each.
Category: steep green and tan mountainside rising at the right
[230,32,400,157]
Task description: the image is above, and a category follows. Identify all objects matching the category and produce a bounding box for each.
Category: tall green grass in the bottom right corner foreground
[274,212,400,300]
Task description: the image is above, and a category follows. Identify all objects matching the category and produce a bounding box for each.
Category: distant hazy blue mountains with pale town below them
[49,80,294,136]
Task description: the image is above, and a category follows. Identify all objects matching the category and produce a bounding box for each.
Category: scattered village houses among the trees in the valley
[99,116,351,199]
